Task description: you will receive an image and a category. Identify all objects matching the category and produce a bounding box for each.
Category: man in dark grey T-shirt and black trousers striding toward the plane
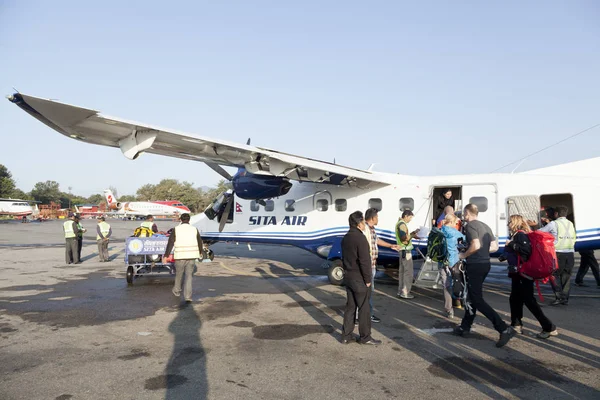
[454,204,517,347]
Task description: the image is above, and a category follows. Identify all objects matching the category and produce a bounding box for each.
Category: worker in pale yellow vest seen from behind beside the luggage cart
[163,213,202,303]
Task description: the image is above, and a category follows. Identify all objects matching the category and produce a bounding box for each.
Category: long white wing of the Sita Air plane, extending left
[9,93,392,187]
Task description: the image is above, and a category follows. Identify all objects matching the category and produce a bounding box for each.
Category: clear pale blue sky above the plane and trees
[0,0,600,195]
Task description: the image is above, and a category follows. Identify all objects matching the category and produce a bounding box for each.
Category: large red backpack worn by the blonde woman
[519,231,558,298]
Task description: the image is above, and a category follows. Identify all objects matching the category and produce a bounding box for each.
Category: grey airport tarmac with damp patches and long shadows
[0,220,600,400]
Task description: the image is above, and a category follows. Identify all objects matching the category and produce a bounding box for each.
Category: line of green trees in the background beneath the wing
[0,164,231,213]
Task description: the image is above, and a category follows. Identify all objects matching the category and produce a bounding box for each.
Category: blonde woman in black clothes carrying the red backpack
[504,215,558,339]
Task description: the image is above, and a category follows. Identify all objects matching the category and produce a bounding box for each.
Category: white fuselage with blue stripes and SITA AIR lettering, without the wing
[192,170,600,263]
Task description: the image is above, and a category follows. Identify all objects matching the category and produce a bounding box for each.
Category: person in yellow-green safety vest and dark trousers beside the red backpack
[540,206,577,306]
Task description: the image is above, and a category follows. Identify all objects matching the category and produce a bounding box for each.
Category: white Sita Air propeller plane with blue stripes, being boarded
[9,94,600,284]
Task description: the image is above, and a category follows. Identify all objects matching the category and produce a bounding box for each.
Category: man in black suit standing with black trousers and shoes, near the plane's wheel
[342,211,381,345]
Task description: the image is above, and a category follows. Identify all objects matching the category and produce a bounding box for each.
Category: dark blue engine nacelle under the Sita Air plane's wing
[231,170,292,200]
